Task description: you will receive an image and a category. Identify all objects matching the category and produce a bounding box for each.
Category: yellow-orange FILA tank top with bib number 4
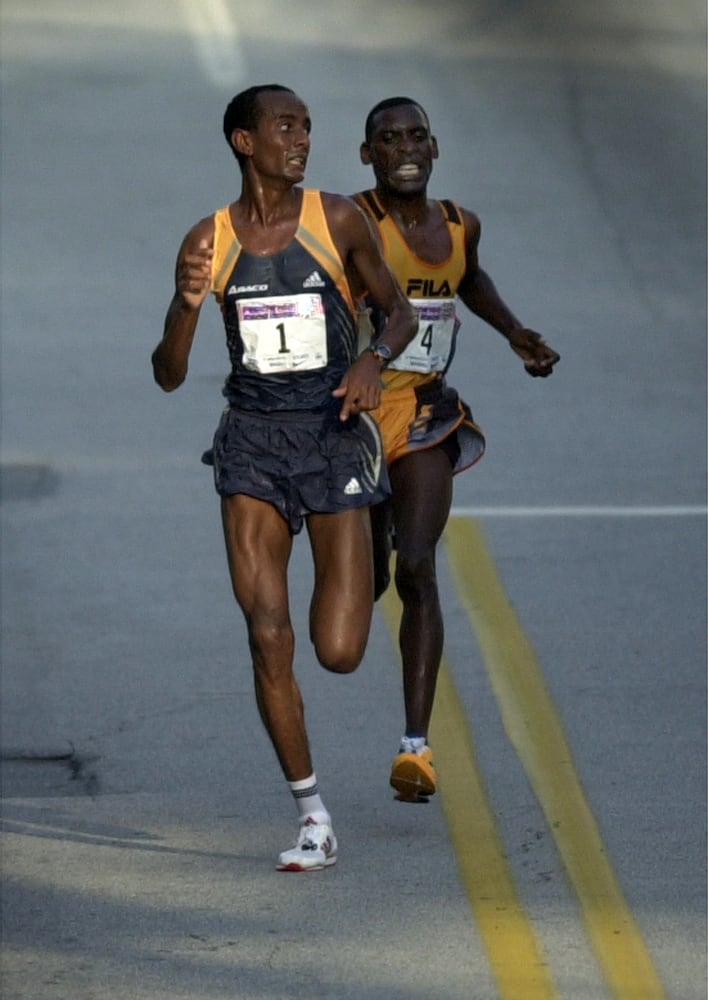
[354,191,467,390]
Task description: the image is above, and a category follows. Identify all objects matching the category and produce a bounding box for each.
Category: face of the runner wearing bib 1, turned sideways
[250,90,311,184]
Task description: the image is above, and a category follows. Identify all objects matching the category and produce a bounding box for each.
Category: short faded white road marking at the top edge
[181,0,247,88]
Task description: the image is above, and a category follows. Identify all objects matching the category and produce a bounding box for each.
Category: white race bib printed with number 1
[236,293,327,375]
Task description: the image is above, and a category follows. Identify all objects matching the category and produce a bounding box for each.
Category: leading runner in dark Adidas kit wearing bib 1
[152,84,417,871]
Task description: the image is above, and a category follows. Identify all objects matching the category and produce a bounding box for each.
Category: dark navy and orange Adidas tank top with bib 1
[211,189,357,413]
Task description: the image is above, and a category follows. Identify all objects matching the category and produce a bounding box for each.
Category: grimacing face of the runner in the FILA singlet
[362,104,438,196]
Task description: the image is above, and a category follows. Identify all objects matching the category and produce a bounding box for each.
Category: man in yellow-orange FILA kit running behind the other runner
[355,97,559,801]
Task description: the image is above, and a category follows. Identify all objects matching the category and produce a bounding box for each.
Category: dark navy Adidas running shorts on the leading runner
[213,407,391,534]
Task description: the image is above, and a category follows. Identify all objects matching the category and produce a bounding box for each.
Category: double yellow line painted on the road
[380,517,665,1000]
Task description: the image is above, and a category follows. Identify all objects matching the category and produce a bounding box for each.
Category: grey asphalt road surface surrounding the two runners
[0,0,706,1000]
